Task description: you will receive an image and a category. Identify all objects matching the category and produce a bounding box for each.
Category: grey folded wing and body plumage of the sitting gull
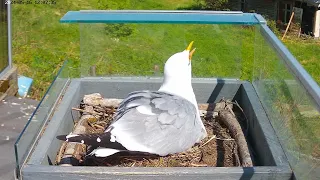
[106,91,205,155]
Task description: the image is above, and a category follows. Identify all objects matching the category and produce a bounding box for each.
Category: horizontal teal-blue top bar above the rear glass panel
[60,10,259,25]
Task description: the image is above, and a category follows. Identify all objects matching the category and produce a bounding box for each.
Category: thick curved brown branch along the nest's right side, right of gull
[217,101,253,167]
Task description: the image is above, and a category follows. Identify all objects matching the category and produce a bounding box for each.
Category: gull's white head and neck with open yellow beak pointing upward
[159,41,197,106]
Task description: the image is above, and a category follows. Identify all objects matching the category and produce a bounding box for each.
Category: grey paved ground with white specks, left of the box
[0,97,38,180]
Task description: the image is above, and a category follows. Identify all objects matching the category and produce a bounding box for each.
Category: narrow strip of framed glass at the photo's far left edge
[0,2,9,72]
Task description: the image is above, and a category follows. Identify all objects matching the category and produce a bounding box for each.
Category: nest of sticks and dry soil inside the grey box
[55,93,253,167]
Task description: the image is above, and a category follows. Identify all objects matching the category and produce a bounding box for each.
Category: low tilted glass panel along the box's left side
[14,62,69,179]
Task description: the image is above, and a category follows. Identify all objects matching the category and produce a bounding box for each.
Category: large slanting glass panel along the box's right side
[253,25,320,179]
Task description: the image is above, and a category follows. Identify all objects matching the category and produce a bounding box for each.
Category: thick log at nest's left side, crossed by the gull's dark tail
[58,115,95,166]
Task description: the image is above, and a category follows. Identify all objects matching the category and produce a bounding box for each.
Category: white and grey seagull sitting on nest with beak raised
[57,41,207,157]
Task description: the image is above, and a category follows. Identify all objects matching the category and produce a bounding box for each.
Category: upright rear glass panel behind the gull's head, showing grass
[80,23,255,79]
